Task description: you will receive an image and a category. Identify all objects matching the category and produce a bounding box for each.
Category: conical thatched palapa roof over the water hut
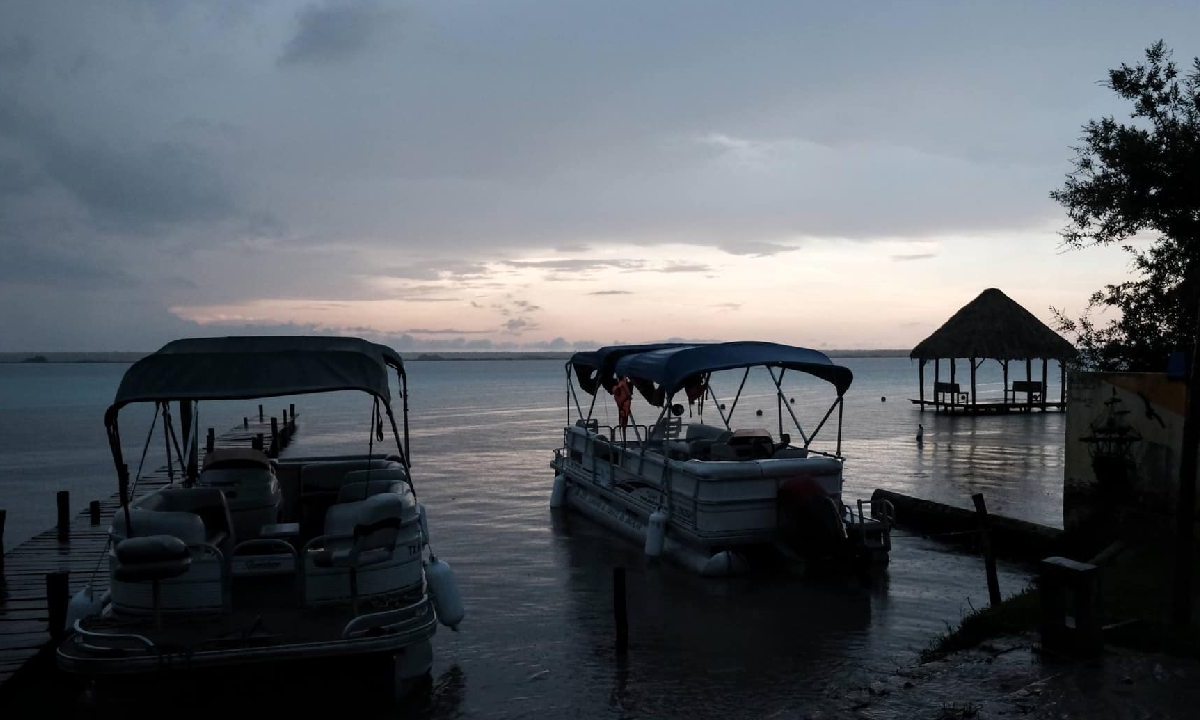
[908,288,1075,360]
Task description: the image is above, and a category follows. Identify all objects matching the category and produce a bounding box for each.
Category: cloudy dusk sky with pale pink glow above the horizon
[0,0,1200,352]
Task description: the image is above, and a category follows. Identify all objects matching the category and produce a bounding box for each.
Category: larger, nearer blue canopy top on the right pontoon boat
[614,342,854,397]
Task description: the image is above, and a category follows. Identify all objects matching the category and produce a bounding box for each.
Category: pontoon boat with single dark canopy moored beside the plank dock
[58,337,463,690]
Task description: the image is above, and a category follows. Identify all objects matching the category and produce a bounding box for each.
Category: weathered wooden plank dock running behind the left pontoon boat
[0,406,296,707]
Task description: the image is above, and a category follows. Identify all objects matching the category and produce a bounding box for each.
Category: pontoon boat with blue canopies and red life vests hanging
[551,342,894,576]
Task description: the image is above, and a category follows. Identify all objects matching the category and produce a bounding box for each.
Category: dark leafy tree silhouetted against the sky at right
[1050,41,1200,371]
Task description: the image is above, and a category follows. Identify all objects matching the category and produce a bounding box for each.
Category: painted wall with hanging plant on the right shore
[1062,372,1187,534]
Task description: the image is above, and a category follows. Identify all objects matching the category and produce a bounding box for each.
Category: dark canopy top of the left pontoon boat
[109,336,404,414]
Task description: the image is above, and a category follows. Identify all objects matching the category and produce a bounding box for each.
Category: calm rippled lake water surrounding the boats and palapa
[0,359,1064,718]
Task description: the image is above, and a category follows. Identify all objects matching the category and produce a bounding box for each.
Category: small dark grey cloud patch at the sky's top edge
[280,2,391,65]
